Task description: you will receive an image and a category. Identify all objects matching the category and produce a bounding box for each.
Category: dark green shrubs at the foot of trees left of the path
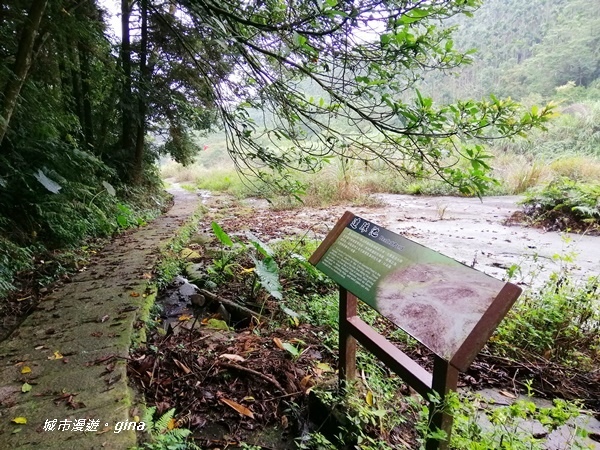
[0,139,165,297]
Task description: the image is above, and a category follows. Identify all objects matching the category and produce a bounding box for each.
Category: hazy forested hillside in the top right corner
[423,0,600,101]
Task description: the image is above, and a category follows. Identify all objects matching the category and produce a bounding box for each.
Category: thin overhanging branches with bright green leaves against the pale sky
[179,0,553,193]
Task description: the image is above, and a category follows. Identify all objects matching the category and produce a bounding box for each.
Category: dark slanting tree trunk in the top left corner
[0,0,47,147]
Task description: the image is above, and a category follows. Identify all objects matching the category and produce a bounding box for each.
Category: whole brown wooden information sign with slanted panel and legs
[310,212,521,450]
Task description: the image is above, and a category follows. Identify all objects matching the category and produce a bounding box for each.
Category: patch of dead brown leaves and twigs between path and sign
[128,325,334,440]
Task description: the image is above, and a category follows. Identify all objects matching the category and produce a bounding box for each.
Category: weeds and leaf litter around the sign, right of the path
[130,205,600,450]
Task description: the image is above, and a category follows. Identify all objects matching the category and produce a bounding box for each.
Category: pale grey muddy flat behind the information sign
[241,194,600,286]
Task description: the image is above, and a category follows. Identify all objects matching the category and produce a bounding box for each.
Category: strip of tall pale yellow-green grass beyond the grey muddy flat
[162,149,600,208]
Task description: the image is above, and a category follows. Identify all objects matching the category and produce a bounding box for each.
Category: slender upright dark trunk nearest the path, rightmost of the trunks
[133,0,149,184]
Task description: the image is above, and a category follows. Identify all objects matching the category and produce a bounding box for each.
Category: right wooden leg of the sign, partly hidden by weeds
[425,355,458,450]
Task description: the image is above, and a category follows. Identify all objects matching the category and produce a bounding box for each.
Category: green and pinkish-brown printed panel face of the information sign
[314,216,506,360]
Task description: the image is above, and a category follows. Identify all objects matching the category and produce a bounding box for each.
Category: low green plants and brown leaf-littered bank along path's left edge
[0,177,170,339]
